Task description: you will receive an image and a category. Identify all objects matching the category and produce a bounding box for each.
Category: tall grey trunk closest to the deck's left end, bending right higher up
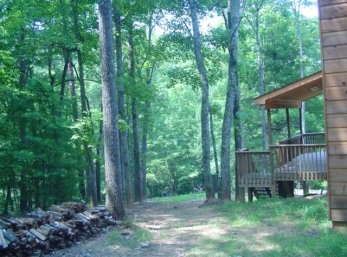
[221,0,240,200]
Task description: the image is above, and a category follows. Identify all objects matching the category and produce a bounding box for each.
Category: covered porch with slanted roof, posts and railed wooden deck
[236,72,327,201]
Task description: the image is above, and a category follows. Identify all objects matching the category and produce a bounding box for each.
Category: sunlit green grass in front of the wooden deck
[196,197,347,257]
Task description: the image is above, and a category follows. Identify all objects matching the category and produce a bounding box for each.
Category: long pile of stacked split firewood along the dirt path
[0,202,117,257]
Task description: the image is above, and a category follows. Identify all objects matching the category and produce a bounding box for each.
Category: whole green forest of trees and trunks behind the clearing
[0,0,324,216]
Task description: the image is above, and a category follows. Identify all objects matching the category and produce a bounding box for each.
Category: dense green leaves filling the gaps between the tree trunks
[0,0,324,212]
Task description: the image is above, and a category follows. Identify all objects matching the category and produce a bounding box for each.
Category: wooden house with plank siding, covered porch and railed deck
[236,0,347,228]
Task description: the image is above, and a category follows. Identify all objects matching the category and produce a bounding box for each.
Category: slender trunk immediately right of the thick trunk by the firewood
[114,5,134,208]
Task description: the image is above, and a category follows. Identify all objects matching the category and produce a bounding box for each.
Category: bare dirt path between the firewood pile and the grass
[52,199,228,257]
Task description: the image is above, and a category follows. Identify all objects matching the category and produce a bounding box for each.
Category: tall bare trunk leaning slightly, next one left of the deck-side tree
[188,0,215,200]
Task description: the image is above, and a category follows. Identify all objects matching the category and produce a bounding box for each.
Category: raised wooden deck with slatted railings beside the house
[236,133,327,200]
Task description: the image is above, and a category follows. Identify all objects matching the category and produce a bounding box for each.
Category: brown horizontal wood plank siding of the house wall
[318,0,347,224]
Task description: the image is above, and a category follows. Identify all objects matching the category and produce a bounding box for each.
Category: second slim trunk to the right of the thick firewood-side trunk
[128,23,143,202]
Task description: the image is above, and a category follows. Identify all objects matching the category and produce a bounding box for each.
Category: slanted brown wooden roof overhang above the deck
[253,71,323,109]
